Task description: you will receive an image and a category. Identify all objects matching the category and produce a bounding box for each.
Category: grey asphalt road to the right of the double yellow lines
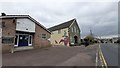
[100,43,120,66]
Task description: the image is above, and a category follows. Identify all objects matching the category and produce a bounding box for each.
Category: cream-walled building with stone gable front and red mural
[48,19,80,46]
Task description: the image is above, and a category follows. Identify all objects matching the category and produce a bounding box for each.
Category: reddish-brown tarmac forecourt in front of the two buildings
[2,44,98,66]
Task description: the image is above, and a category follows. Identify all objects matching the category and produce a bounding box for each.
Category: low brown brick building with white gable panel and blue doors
[0,14,51,52]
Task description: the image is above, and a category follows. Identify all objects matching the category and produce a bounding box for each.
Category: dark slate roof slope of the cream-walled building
[48,19,75,31]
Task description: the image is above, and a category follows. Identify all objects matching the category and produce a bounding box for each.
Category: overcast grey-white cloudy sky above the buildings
[0,0,118,37]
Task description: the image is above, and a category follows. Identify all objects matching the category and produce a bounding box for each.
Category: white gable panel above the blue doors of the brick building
[16,18,35,32]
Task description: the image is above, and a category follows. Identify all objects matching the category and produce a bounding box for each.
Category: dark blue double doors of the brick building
[18,35,29,47]
